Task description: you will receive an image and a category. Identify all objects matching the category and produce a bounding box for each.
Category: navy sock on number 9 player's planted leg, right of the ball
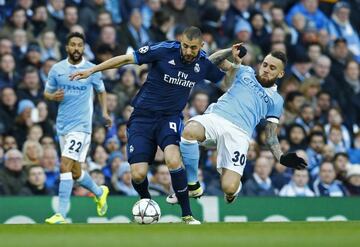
[170,167,192,216]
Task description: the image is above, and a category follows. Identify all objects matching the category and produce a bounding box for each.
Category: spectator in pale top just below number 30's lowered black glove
[279,170,315,197]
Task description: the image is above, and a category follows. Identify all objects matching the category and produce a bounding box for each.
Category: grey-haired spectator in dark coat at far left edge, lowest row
[0,149,26,196]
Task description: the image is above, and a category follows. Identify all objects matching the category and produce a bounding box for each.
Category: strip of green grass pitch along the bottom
[0,221,360,247]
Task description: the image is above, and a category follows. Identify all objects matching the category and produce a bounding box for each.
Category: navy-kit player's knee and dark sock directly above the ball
[130,162,151,199]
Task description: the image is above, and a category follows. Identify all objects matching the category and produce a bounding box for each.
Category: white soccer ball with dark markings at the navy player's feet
[132,199,161,224]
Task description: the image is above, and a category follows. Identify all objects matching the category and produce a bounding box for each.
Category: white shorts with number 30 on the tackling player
[189,113,250,176]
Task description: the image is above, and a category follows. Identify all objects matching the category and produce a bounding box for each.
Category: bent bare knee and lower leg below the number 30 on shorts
[221,168,242,203]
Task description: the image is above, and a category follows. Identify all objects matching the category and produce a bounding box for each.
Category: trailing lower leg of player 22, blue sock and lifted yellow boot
[77,169,109,216]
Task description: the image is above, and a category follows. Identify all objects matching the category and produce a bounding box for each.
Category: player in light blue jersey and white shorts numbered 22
[44,33,112,224]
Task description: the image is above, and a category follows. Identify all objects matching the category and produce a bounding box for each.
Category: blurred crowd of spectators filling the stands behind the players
[0,0,360,197]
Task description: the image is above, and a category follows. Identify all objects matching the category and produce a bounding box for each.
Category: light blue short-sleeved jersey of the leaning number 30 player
[207,66,284,137]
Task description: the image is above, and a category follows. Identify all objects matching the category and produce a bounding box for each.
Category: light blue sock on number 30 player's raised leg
[180,137,200,184]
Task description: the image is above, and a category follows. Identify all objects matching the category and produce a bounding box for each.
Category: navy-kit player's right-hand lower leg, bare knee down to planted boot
[164,145,200,225]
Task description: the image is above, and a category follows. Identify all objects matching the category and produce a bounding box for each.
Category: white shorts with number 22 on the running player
[59,132,91,162]
